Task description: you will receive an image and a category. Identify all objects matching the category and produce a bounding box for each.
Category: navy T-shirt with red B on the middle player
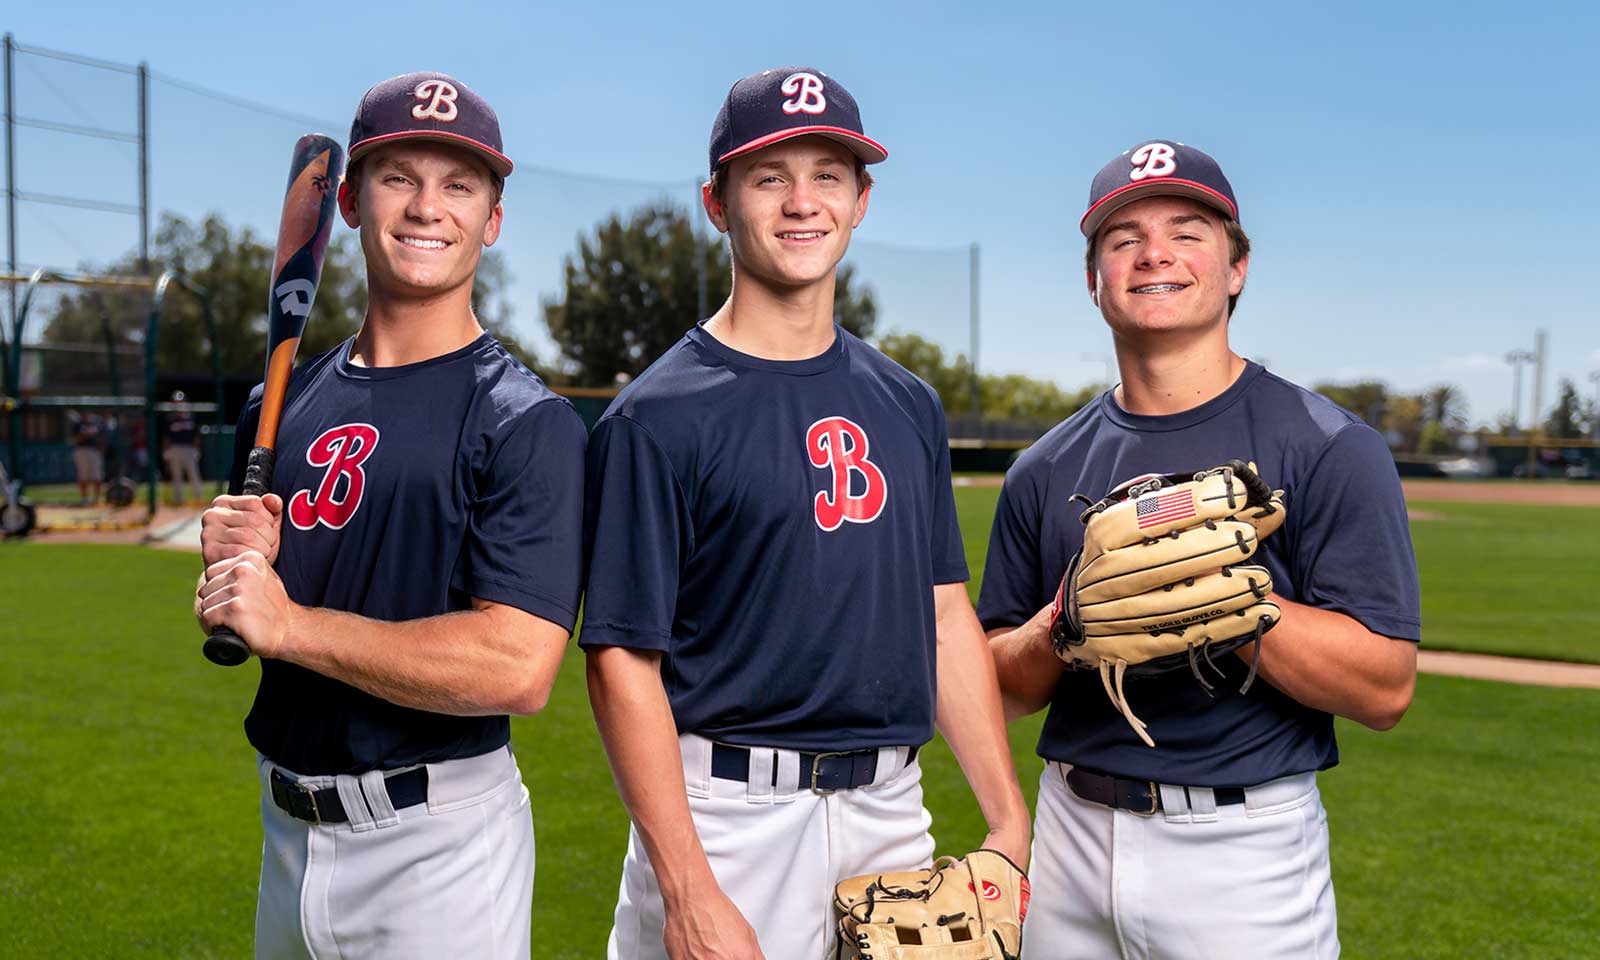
[579,326,966,750]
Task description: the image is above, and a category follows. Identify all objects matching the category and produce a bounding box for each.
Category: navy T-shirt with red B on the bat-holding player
[232,333,586,774]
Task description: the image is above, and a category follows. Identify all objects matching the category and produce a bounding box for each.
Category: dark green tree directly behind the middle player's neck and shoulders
[544,203,877,386]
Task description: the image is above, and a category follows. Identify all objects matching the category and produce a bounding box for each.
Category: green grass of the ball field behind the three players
[0,488,1600,960]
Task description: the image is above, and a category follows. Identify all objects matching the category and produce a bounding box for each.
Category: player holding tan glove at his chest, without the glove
[978,141,1421,960]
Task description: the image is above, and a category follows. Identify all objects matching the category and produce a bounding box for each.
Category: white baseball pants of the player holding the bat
[256,747,533,960]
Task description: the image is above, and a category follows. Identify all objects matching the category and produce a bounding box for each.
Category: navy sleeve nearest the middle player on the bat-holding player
[451,400,586,632]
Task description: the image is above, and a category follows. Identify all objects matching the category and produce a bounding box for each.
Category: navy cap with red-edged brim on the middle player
[710,67,890,173]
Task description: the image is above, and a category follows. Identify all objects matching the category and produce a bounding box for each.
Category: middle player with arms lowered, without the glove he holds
[579,67,1027,960]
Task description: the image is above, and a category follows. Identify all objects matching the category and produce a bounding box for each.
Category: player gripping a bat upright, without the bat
[197,74,584,958]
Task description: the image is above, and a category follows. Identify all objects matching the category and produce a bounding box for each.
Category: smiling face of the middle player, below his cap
[704,136,870,288]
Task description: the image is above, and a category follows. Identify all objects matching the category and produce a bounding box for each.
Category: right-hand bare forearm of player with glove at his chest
[1238,594,1416,730]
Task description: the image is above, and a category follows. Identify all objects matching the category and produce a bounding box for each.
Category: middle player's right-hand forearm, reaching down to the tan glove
[934,592,1029,854]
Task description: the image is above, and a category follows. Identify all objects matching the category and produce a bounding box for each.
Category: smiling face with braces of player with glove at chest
[1088,197,1250,334]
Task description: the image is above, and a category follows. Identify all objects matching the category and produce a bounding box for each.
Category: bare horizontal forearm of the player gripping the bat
[274,602,566,717]
